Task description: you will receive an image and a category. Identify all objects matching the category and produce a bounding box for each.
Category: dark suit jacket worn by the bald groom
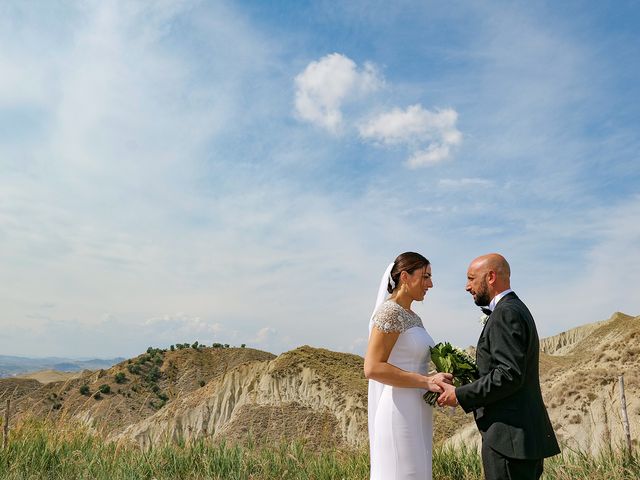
[456,292,560,459]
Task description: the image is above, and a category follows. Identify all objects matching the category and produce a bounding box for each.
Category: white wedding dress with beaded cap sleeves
[368,300,435,480]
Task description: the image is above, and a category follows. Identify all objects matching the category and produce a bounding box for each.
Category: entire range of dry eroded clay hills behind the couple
[0,313,640,452]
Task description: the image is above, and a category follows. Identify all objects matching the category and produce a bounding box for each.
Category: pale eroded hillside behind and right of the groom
[448,313,640,453]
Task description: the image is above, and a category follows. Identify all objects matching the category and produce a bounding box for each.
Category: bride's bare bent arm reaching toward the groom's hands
[364,327,451,393]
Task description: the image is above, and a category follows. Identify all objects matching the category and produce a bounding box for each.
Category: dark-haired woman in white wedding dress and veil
[364,252,452,480]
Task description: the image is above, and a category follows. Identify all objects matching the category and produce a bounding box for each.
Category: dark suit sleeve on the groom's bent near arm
[456,309,530,412]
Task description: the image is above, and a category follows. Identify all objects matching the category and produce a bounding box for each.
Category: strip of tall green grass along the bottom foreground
[0,420,640,480]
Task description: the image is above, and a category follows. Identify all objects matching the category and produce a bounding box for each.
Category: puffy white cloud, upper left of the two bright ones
[295,53,383,132]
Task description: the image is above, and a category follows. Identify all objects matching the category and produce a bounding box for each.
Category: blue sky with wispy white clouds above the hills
[0,0,640,357]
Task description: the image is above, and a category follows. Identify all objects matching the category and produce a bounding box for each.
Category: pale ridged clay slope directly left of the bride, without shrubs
[117,346,367,447]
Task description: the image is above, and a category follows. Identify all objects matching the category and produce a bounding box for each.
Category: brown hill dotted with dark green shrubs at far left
[0,348,275,434]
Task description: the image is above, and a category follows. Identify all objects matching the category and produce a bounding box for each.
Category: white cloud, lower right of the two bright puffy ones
[360,104,462,168]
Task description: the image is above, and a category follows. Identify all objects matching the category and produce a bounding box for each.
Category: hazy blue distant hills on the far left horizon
[0,355,124,378]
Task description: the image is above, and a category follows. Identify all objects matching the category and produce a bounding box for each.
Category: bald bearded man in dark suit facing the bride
[438,253,560,480]
